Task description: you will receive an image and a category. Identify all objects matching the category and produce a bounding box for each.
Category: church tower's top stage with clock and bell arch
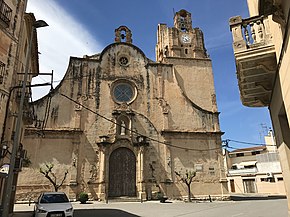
[156,10,208,62]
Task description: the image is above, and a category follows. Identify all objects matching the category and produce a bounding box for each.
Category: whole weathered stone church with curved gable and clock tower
[17,10,227,200]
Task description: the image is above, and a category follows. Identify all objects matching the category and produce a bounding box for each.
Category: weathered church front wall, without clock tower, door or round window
[19,32,227,199]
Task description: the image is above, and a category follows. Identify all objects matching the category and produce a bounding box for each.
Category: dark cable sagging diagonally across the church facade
[59,93,221,151]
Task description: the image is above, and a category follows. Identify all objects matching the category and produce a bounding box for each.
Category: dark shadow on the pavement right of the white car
[74,209,140,217]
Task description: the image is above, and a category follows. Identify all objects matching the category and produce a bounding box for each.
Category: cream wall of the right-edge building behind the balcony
[269,1,290,215]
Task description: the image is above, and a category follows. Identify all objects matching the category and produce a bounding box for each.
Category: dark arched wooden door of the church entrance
[109,148,136,197]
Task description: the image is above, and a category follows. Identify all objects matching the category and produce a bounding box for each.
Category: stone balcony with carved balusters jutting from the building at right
[229,16,277,107]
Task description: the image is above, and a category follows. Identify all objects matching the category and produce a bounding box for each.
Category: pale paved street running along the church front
[15,199,287,217]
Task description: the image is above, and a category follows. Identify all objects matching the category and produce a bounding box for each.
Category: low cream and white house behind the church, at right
[226,131,286,195]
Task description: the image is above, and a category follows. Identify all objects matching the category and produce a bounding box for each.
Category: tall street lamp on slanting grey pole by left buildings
[2,20,48,217]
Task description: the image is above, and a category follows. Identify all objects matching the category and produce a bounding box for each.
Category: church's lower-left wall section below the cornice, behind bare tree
[16,131,81,201]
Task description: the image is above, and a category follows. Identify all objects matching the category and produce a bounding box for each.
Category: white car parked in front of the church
[34,192,73,217]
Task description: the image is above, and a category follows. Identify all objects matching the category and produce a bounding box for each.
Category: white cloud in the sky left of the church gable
[26,0,101,99]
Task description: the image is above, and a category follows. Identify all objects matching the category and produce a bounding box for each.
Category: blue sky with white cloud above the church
[27,0,271,147]
